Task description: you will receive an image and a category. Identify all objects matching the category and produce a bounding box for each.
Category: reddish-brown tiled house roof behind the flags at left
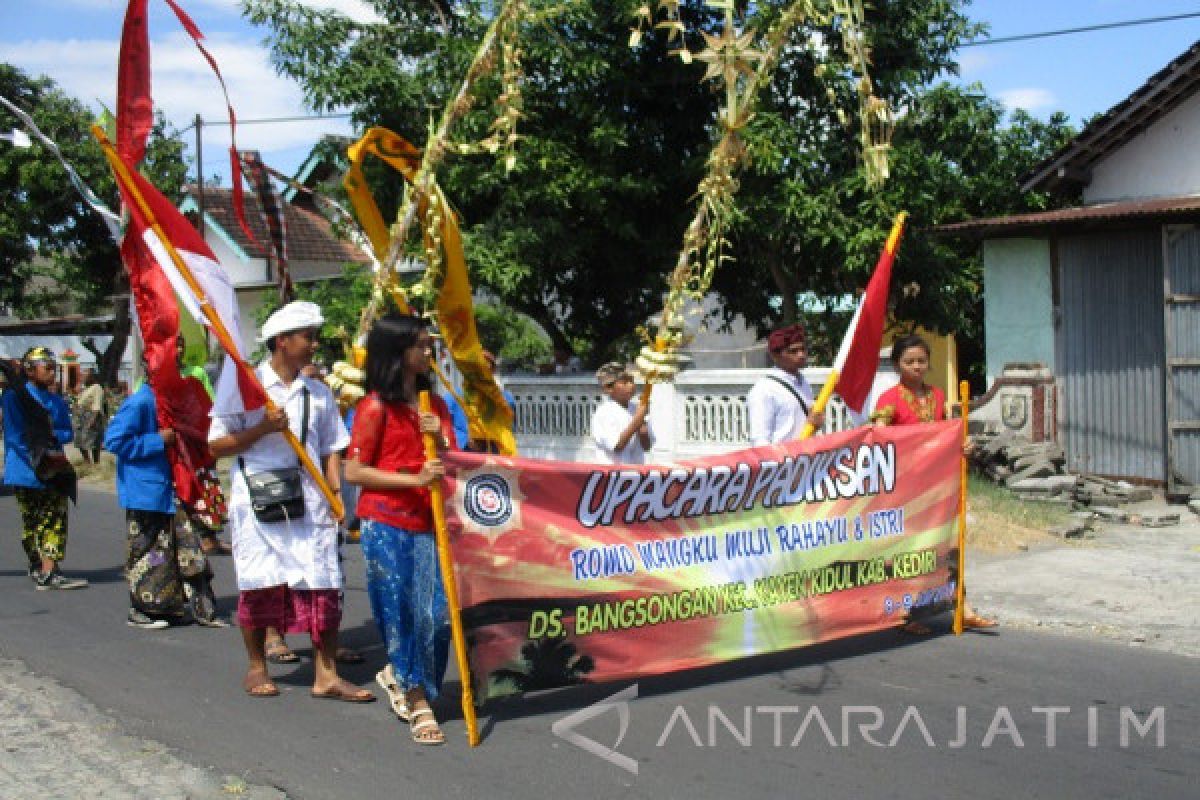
[185,185,371,264]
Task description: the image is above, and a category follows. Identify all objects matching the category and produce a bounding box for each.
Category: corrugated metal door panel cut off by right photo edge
[1166,225,1200,489]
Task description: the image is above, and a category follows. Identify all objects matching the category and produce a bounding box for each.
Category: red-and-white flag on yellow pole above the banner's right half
[833,212,907,414]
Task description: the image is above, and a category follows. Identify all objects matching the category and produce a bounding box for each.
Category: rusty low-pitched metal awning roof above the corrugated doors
[935,196,1200,239]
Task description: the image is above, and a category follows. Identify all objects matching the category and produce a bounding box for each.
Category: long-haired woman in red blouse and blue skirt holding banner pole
[346,314,454,745]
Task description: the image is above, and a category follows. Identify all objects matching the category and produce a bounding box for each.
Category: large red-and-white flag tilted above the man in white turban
[116,163,266,414]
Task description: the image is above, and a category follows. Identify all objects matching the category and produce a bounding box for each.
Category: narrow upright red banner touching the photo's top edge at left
[116,0,154,167]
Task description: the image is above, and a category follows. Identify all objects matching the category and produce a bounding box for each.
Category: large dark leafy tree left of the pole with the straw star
[244,0,713,360]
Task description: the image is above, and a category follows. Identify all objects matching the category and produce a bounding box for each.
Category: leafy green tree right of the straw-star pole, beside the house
[714,0,1073,381]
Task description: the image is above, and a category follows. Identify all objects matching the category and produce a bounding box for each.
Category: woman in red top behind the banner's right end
[871,336,996,636]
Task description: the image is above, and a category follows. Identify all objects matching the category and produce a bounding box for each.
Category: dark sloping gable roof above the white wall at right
[1021,41,1200,193]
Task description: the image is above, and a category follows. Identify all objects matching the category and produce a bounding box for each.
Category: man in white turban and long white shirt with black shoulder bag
[209,301,374,703]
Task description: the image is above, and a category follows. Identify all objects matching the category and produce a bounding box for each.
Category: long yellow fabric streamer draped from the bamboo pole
[342,127,517,456]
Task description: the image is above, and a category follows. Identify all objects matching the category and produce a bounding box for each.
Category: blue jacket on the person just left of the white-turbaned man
[104,384,175,513]
